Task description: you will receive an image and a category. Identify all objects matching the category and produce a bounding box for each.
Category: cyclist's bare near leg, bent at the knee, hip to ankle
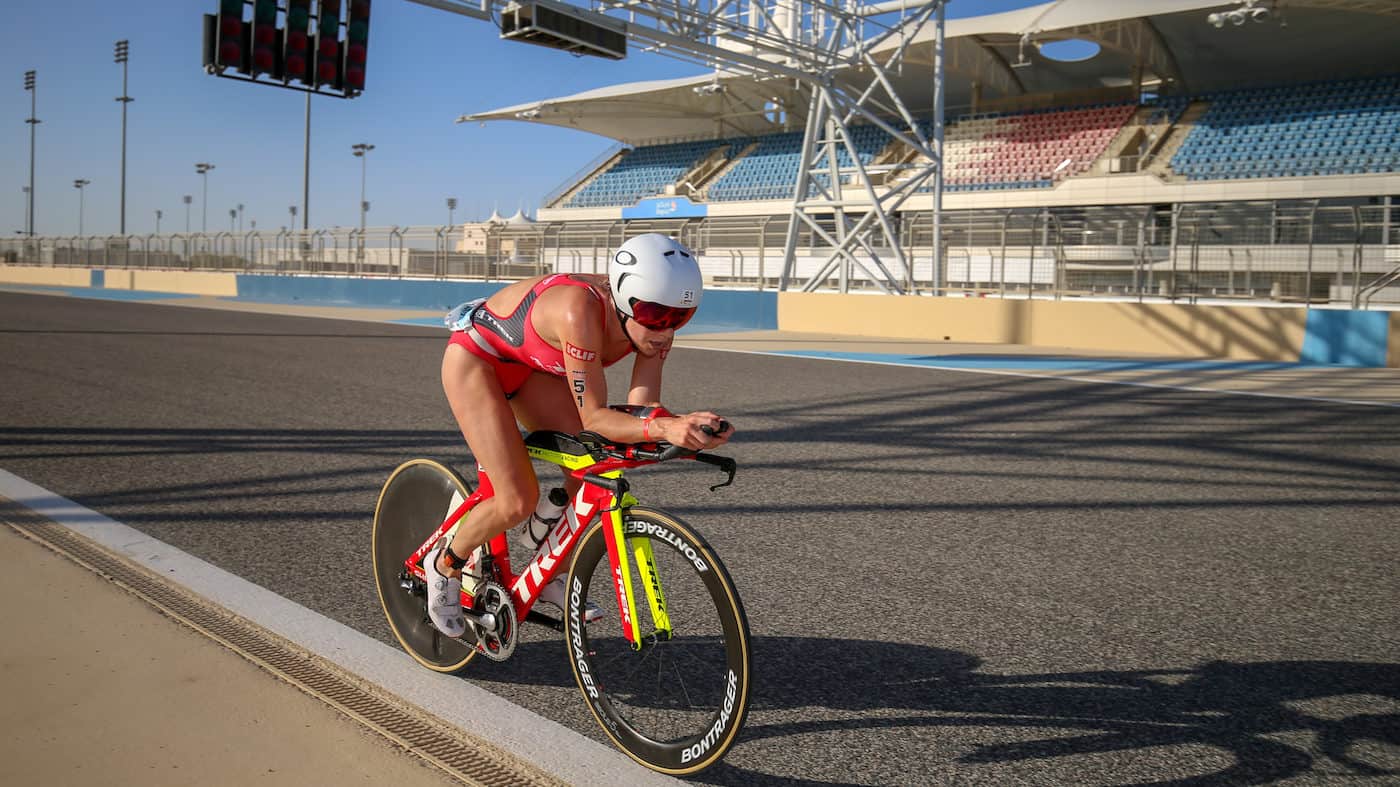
[438,344,539,576]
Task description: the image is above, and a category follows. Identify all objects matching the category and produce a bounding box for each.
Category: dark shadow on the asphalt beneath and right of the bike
[484,636,1400,787]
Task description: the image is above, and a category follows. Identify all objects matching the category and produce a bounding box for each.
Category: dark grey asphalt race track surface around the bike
[0,293,1400,786]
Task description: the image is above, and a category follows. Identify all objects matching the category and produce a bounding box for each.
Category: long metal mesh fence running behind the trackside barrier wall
[0,199,1400,308]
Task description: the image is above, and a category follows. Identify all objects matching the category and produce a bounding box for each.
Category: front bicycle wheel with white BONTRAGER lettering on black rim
[564,507,752,774]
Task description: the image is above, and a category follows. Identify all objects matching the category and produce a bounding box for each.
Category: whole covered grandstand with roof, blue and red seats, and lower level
[463,0,1400,302]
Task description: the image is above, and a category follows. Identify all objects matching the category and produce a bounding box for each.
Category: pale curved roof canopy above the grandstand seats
[458,0,1400,144]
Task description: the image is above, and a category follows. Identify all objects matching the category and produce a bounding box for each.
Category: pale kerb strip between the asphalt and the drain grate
[0,469,680,787]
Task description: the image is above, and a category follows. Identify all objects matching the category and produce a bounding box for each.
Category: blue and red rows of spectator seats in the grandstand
[529,70,1400,200]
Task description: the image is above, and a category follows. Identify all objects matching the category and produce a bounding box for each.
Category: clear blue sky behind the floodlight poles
[0,0,1035,235]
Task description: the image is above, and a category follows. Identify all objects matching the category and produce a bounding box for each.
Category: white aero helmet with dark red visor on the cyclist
[608,232,704,330]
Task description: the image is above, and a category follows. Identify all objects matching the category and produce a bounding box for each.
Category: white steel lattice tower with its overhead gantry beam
[414,0,963,293]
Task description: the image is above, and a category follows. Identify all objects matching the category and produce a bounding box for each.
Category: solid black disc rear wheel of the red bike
[371,459,476,672]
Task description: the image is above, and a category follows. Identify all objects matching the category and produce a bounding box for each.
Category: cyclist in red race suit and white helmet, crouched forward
[424,234,734,637]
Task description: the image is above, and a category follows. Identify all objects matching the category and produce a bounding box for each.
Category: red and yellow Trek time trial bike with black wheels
[372,406,752,774]
